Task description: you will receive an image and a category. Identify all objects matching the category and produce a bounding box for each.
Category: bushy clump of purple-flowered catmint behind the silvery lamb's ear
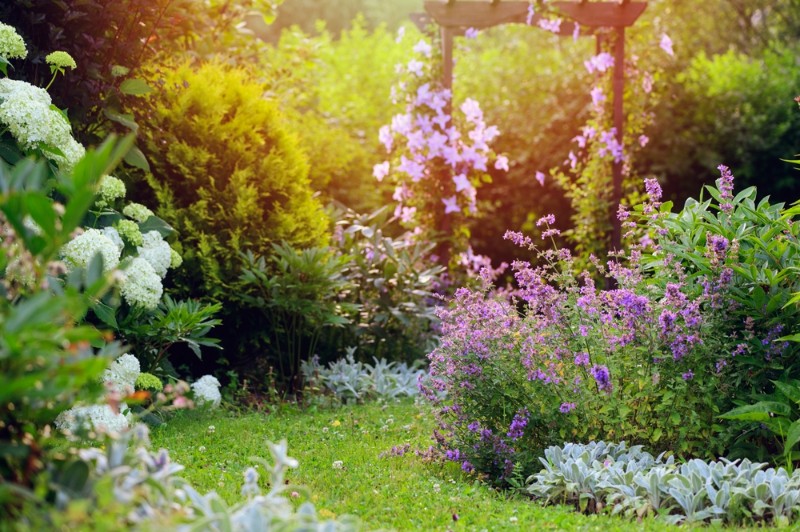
[424,172,756,484]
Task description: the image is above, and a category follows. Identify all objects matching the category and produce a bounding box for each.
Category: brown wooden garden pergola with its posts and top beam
[412,0,647,254]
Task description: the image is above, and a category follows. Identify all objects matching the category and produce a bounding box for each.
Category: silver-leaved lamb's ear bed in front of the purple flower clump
[527,442,800,526]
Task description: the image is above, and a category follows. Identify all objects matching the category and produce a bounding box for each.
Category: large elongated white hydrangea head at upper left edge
[0,78,86,171]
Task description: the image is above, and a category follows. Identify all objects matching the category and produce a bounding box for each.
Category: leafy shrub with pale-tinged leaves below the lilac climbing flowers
[318,207,445,363]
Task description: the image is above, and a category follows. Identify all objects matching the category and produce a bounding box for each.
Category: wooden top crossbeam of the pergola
[425,0,647,28]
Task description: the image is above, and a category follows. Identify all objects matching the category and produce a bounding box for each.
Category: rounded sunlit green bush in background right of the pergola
[641,43,800,202]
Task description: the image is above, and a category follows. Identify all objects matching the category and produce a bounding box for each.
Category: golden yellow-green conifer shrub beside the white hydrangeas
[133,62,329,296]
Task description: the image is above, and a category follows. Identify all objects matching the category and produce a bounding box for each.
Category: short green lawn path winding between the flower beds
[152,401,708,531]
